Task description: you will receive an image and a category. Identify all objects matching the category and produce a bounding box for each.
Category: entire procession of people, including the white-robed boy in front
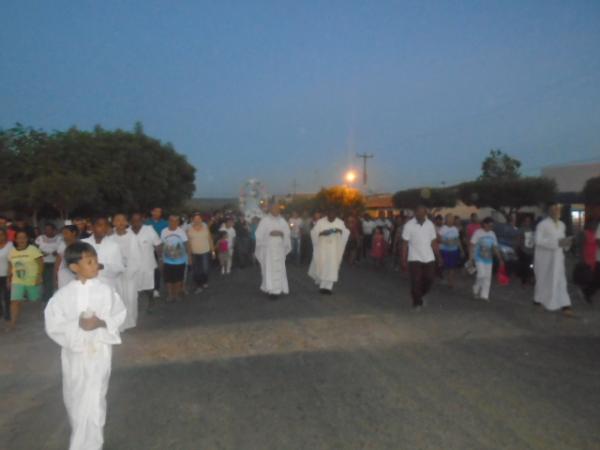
[0,204,600,448]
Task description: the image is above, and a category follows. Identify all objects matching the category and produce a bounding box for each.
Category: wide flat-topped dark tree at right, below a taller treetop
[458,177,557,219]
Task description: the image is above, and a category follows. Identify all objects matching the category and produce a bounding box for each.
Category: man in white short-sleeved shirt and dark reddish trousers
[402,206,442,311]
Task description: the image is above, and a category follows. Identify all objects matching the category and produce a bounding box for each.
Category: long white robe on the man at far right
[533,217,571,311]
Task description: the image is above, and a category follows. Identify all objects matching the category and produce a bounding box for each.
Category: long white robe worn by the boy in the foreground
[44,278,126,450]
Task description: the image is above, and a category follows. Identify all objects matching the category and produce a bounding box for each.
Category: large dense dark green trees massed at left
[0,123,195,218]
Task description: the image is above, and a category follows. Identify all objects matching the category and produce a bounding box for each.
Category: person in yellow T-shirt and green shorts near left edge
[8,229,44,331]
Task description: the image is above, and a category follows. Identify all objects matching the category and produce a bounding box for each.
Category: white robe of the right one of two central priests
[308,217,350,289]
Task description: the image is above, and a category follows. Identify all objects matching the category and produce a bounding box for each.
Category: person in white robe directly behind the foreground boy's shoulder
[81,217,125,289]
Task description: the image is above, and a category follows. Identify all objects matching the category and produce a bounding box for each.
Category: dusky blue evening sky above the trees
[0,0,600,197]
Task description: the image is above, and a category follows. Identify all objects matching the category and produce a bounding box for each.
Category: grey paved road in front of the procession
[0,267,600,450]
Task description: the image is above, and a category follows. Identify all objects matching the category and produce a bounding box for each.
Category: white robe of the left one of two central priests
[255,214,292,295]
